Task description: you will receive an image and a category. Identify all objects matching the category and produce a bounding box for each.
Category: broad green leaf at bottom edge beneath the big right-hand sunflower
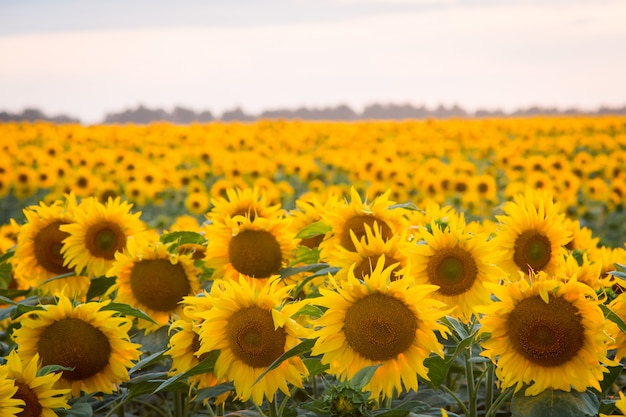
[511,388,600,417]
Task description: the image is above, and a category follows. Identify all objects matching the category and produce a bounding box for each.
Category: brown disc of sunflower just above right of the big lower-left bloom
[130,259,191,311]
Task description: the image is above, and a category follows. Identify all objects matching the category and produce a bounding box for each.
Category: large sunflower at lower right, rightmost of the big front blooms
[477,272,615,395]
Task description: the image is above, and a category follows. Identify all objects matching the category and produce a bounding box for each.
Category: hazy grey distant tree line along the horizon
[0,104,626,124]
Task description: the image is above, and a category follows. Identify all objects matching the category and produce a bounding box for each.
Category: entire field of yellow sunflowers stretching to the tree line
[0,116,626,417]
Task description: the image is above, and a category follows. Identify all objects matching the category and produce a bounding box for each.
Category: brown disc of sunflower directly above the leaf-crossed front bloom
[228,230,282,278]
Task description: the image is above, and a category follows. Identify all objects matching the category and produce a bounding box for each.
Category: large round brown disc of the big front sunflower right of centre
[343,293,417,361]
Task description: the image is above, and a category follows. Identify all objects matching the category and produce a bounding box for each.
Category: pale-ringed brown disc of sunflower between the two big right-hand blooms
[427,247,478,296]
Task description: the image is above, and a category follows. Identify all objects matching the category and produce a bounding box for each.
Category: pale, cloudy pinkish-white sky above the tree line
[0,0,626,123]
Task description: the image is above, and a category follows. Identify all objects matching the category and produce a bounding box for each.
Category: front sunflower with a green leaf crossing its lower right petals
[196,276,308,405]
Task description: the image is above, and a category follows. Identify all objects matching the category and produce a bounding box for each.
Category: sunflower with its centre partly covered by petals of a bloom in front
[319,188,406,264]
